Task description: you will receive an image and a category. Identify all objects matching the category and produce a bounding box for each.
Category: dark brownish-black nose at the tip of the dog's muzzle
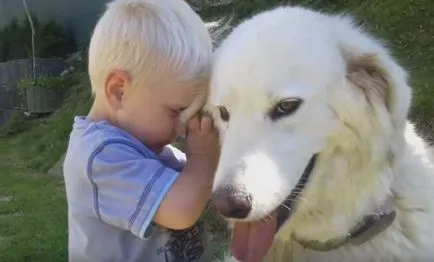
[211,186,252,219]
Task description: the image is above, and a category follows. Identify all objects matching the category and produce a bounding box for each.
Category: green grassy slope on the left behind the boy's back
[0,74,90,262]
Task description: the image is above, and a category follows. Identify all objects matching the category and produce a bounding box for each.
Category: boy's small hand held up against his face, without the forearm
[186,114,219,162]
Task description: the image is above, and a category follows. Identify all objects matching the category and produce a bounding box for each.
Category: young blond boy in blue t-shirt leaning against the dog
[64,0,218,262]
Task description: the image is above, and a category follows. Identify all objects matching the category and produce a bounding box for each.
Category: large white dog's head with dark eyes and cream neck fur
[207,7,411,260]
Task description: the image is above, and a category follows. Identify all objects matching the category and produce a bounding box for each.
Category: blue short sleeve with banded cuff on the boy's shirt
[88,140,178,238]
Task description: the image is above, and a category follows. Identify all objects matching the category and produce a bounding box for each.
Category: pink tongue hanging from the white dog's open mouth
[231,211,277,262]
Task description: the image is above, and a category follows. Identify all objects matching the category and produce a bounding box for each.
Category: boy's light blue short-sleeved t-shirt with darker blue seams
[63,116,211,262]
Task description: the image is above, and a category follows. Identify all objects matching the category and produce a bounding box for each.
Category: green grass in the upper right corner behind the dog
[346,0,434,137]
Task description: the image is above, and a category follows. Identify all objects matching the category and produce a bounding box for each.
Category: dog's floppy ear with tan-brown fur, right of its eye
[341,29,411,129]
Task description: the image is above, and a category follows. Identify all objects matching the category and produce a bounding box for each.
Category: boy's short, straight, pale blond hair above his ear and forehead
[88,0,212,93]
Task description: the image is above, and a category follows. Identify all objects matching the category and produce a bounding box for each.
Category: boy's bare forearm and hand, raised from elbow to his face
[154,115,220,230]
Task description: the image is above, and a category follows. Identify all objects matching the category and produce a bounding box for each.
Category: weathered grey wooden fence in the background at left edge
[0,58,65,127]
